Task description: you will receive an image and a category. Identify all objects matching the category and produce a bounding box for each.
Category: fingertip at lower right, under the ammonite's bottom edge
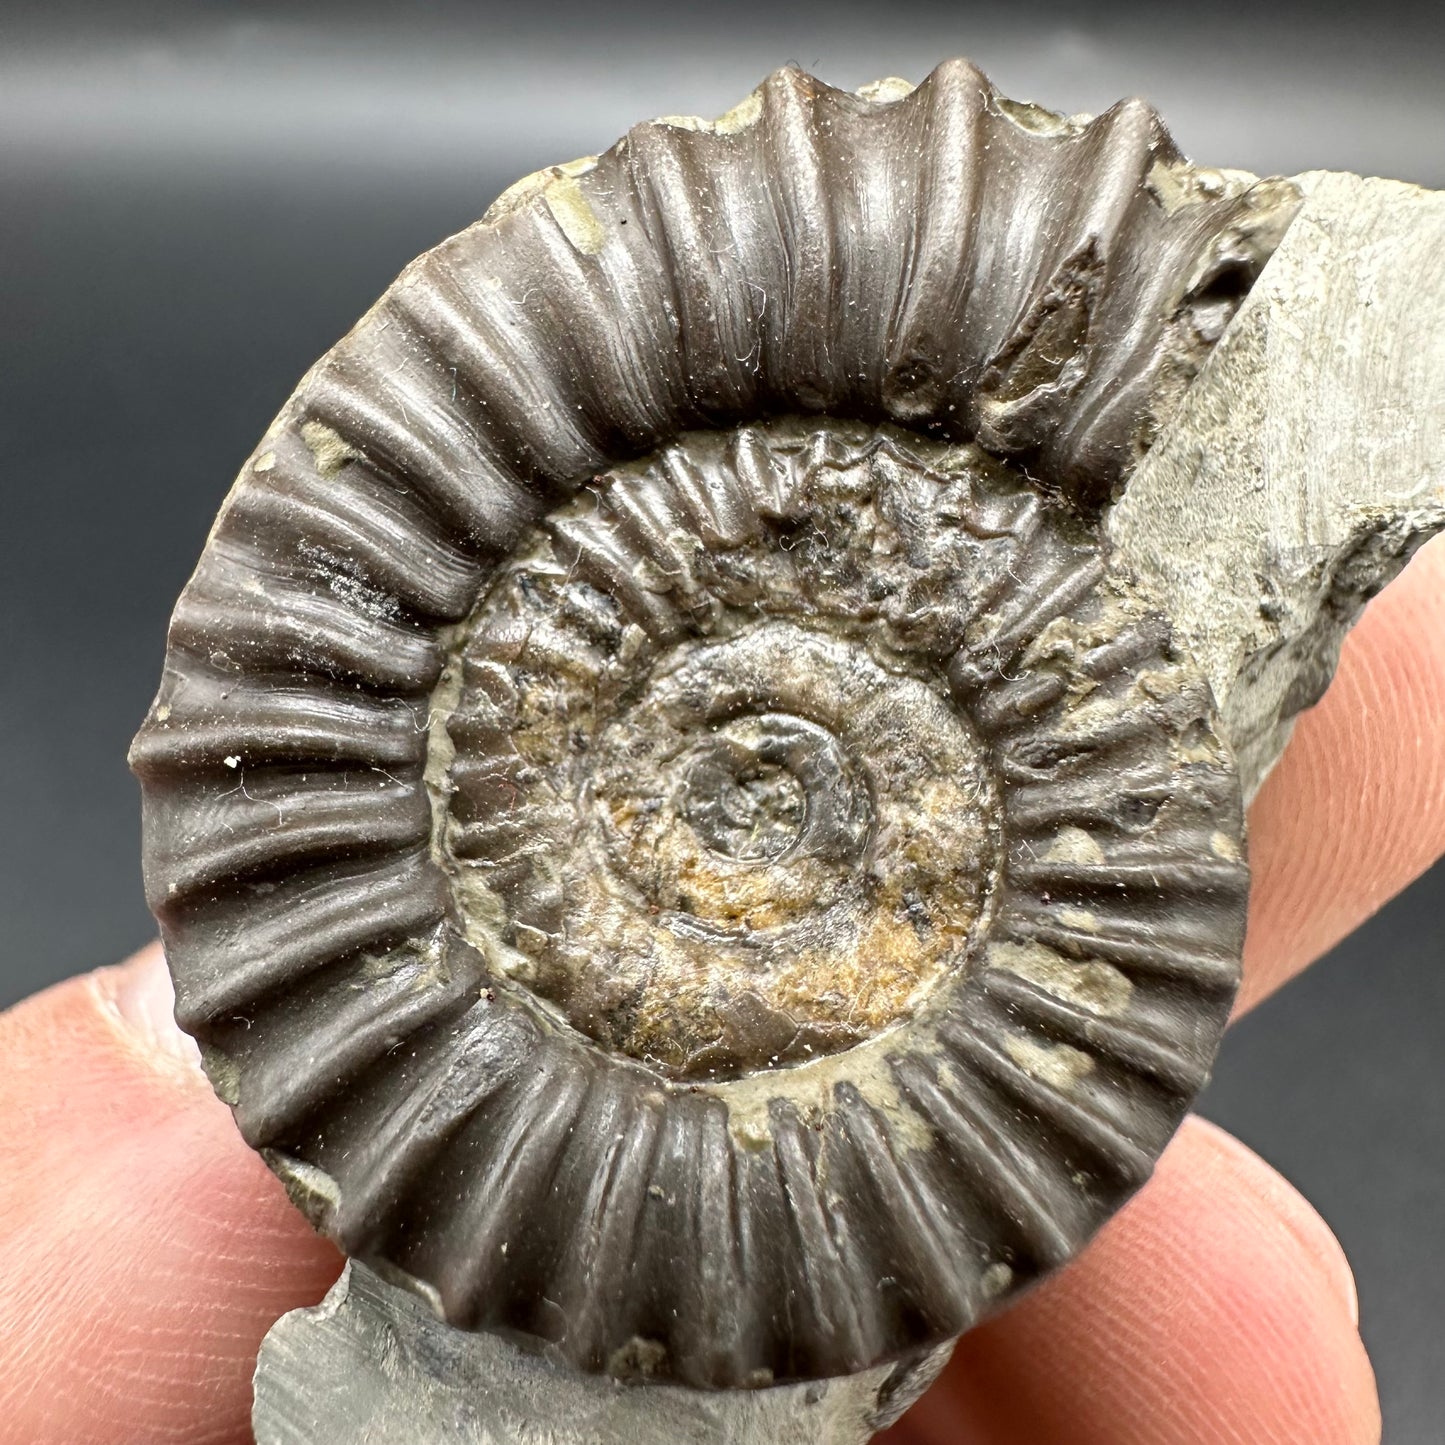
[880,1118,1380,1445]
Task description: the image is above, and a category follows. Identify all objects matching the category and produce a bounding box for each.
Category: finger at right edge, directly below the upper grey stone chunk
[1238,525,1445,1012]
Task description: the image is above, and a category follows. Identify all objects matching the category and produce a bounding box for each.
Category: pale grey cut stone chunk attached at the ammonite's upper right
[1108,172,1445,795]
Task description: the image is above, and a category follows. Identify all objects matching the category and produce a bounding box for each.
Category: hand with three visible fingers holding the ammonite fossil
[0,539,1445,1445]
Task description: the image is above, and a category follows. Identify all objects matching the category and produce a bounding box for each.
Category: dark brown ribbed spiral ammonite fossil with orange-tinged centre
[133,62,1293,1387]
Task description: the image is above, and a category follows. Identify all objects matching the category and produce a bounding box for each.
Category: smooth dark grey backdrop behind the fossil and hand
[0,0,1445,1445]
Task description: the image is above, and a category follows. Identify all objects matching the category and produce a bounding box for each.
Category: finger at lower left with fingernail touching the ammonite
[0,945,340,1445]
